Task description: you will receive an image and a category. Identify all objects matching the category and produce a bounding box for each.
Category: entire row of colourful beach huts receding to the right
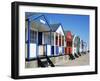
[25,14,88,67]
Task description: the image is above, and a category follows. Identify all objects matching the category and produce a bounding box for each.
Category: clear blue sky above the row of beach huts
[26,13,89,48]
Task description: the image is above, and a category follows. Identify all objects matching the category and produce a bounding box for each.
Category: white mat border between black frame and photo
[19,6,95,75]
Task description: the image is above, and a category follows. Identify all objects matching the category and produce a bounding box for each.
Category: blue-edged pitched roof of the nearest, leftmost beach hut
[27,13,51,31]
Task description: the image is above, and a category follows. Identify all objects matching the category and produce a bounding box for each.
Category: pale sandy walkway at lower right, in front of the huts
[55,54,89,66]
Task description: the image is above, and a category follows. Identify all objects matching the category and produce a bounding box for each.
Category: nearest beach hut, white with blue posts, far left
[25,14,51,60]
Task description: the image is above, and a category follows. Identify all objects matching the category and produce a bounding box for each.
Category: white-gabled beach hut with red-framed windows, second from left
[50,23,66,56]
